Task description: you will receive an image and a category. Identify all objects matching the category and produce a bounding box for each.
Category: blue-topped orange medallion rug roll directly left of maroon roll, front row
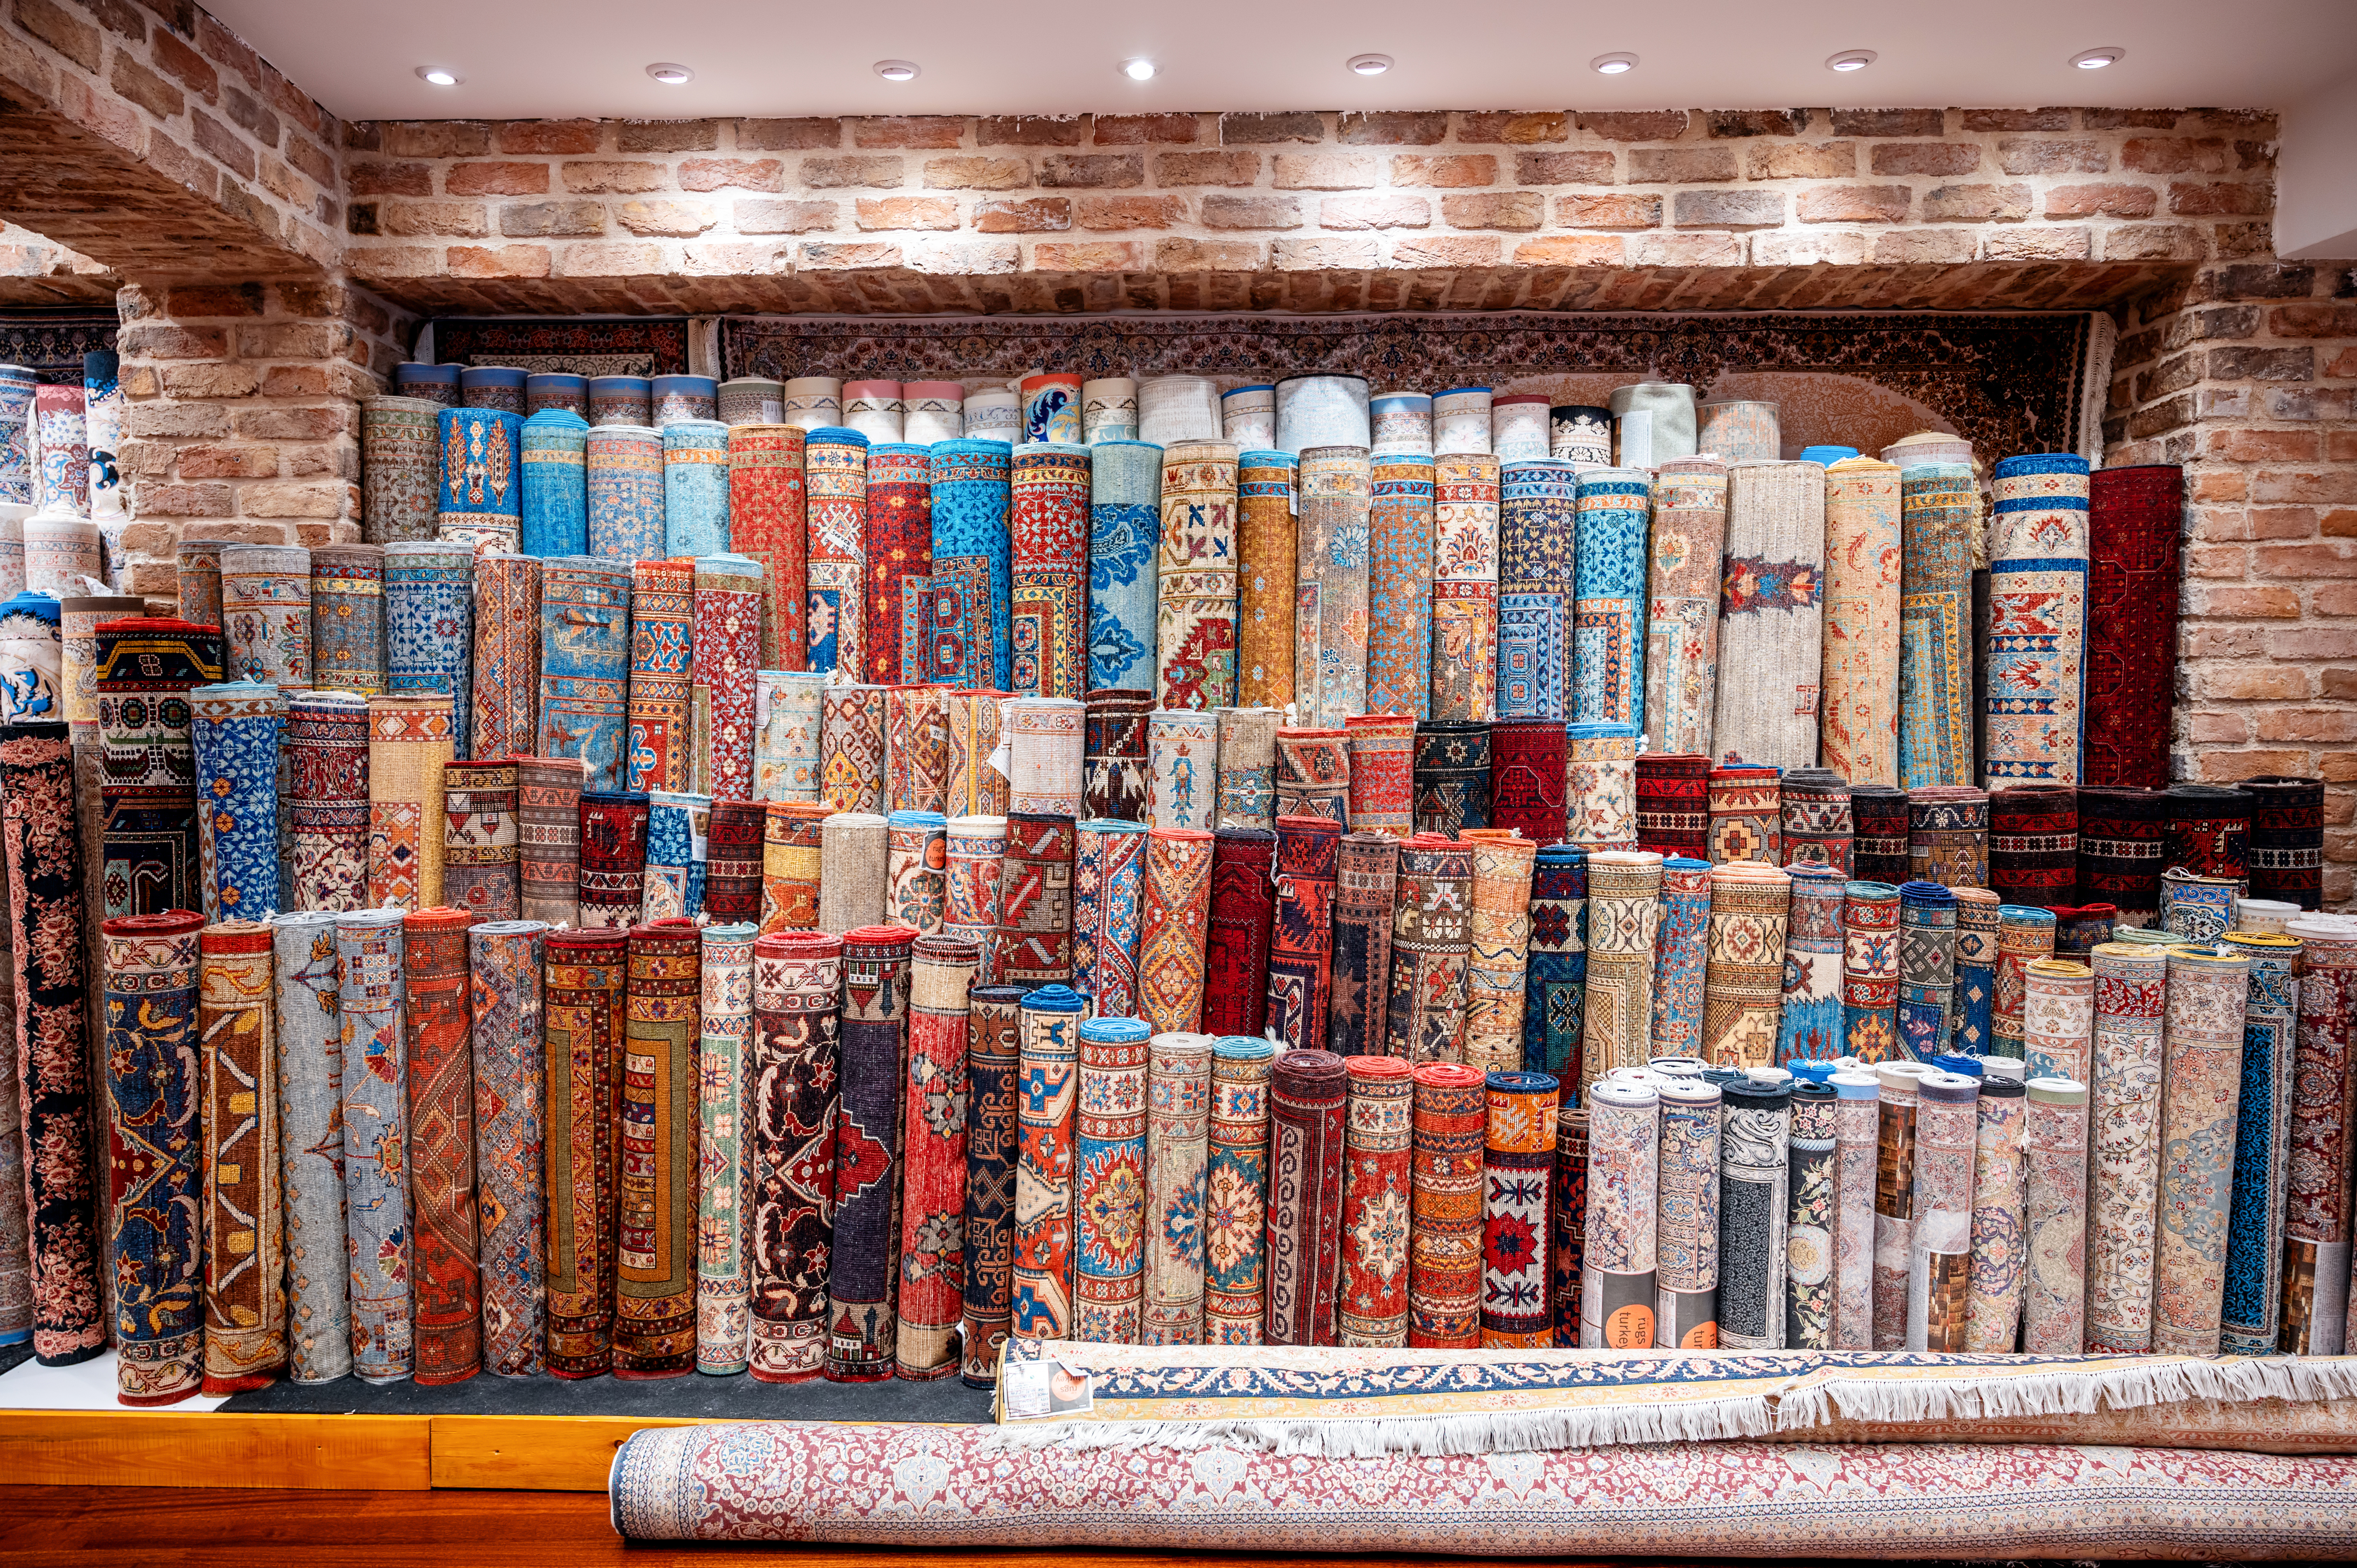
[1202,1035,1277,1344]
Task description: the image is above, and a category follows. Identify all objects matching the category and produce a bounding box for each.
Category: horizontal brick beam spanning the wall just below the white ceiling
[344,108,2274,311]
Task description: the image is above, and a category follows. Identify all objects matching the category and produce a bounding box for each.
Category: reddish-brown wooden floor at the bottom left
[0,1485,1706,1568]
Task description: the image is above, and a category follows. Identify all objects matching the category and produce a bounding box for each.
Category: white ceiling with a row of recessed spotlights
[205,0,2357,120]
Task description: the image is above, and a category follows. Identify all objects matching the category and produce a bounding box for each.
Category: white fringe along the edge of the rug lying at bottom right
[985,1356,2357,1460]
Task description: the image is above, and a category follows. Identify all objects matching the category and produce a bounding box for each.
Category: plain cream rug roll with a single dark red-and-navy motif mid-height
[1711,462,1825,769]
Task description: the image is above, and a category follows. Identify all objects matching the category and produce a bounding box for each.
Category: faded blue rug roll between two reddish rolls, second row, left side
[537,557,632,790]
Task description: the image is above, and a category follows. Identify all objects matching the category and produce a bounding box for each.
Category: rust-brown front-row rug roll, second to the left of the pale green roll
[540,931,627,1377]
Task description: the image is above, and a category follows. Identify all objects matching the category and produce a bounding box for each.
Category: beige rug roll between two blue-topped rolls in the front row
[1136,1033,1216,1344]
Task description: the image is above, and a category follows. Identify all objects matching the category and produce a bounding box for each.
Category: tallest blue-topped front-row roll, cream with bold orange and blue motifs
[1009,985,1086,1339]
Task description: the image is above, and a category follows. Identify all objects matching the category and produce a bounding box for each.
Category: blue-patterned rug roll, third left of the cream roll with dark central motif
[1497,458,1579,719]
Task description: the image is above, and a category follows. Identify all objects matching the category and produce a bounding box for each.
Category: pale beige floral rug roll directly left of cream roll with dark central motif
[1650,460,1728,754]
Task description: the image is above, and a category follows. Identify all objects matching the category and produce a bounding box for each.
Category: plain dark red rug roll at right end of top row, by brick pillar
[2079,464,2185,790]
